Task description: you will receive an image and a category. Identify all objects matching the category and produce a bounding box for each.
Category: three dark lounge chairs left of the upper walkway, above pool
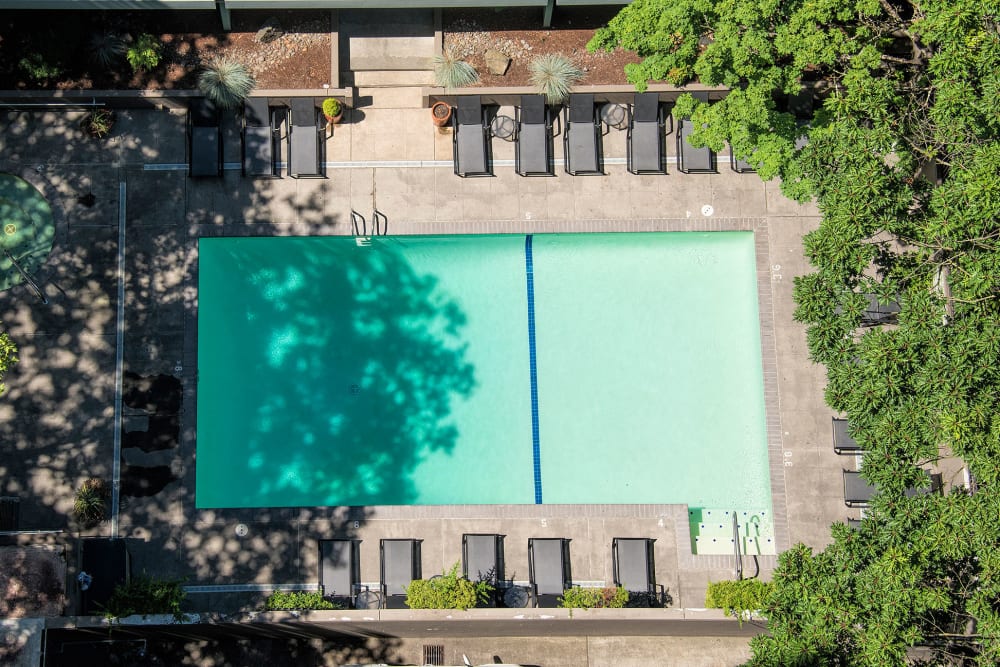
[188,97,325,178]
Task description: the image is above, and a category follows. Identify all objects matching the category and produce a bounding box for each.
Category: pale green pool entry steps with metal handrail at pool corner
[688,508,777,556]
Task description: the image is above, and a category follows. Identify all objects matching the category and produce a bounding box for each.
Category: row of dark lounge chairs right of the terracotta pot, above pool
[452,93,720,178]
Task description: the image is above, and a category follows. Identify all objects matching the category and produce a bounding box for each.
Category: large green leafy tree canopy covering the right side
[590,0,1000,665]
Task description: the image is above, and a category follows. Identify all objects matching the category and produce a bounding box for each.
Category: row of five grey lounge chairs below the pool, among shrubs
[319,533,665,609]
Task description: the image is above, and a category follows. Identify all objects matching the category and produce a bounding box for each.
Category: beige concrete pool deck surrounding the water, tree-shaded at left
[0,89,844,656]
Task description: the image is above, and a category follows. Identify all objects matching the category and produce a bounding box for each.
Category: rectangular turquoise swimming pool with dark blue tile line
[196,232,771,511]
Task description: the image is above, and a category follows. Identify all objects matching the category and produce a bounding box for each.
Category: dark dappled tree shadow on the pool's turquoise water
[198,237,475,507]
